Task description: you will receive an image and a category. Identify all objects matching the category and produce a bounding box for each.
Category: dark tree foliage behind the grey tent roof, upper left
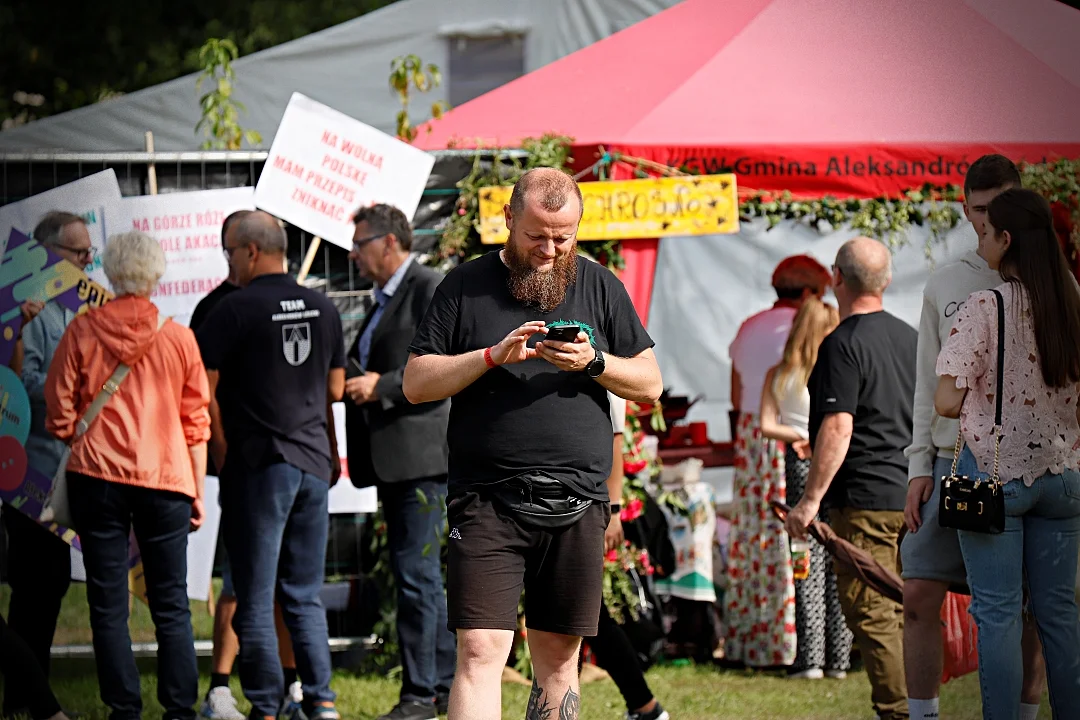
[0,0,393,124]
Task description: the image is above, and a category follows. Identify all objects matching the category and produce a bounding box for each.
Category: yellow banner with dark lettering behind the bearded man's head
[480,175,739,245]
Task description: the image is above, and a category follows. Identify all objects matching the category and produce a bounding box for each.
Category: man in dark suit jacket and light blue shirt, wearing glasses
[346,205,456,720]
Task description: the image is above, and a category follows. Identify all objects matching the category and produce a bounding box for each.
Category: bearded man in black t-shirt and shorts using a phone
[403,168,662,720]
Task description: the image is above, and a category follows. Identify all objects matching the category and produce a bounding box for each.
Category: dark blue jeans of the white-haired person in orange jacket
[68,473,199,720]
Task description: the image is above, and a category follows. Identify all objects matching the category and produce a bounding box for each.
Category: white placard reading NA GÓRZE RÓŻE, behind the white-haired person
[108,188,255,325]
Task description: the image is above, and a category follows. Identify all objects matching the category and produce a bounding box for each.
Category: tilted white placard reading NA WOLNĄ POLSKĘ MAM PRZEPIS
[255,93,435,249]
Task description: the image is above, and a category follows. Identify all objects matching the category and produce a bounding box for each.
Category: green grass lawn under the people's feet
[0,584,1050,720]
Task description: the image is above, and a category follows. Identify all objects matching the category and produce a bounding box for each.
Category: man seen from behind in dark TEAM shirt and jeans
[197,212,346,720]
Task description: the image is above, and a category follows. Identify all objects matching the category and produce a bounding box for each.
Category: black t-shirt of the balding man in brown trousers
[809,311,919,511]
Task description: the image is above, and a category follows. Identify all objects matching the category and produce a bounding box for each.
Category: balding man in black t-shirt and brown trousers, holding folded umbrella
[786,237,918,720]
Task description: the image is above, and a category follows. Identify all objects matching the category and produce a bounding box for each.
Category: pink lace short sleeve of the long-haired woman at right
[936,290,998,388]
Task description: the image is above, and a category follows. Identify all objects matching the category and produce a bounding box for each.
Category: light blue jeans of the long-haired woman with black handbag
[957,449,1080,720]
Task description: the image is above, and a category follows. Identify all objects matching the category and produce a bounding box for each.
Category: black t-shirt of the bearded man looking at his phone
[409,253,653,500]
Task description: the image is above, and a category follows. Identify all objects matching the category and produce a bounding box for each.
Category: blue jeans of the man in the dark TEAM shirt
[221,463,335,718]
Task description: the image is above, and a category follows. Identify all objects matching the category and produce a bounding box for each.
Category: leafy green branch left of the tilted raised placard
[195,38,262,150]
